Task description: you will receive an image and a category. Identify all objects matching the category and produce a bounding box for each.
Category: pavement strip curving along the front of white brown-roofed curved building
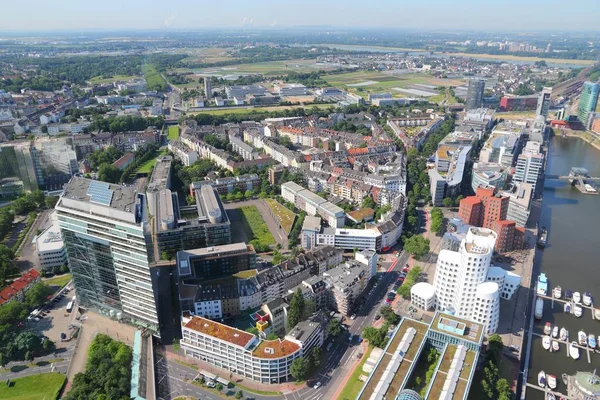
[165,349,306,393]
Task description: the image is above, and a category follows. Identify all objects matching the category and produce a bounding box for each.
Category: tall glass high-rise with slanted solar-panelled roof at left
[56,177,158,330]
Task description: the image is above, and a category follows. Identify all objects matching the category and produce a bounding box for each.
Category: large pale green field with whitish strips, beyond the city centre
[323,71,464,98]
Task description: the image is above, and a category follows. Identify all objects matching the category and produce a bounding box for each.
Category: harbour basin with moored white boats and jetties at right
[520,137,600,400]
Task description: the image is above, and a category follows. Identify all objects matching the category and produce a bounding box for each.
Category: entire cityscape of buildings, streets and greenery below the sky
[0,31,600,400]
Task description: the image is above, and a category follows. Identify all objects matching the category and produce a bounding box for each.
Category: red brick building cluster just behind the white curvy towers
[458,188,525,253]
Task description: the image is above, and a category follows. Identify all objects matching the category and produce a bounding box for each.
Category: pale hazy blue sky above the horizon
[0,0,600,31]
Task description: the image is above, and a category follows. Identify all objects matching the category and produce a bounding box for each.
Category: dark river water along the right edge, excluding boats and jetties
[526,136,600,400]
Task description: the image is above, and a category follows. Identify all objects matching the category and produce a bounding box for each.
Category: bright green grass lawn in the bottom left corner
[0,373,66,400]
